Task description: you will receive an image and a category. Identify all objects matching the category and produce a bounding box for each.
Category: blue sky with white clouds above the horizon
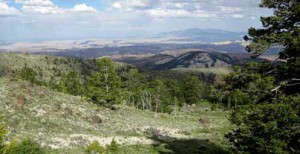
[0,0,272,42]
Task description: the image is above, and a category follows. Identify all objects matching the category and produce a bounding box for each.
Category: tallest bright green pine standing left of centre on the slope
[86,58,121,105]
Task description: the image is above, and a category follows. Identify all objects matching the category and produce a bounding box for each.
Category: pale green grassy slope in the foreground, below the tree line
[0,78,232,153]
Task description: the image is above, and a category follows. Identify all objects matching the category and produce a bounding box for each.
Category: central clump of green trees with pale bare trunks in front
[118,66,200,113]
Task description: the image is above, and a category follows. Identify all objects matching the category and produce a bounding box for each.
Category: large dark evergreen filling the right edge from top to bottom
[225,0,300,153]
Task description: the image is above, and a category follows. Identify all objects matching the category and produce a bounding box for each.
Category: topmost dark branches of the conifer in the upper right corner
[247,0,300,59]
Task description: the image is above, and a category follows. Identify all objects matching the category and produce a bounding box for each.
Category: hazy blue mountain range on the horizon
[156,28,247,43]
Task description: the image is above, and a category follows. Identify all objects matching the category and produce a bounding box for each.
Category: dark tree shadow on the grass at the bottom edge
[149,128,229,154]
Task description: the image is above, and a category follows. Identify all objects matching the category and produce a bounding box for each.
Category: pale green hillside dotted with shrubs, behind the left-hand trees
[0,53,96,82]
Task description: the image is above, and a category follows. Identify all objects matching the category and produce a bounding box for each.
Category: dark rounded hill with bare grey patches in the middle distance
[114,49,238,70]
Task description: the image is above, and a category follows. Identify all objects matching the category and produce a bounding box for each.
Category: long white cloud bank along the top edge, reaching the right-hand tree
[110,0,270,19]
